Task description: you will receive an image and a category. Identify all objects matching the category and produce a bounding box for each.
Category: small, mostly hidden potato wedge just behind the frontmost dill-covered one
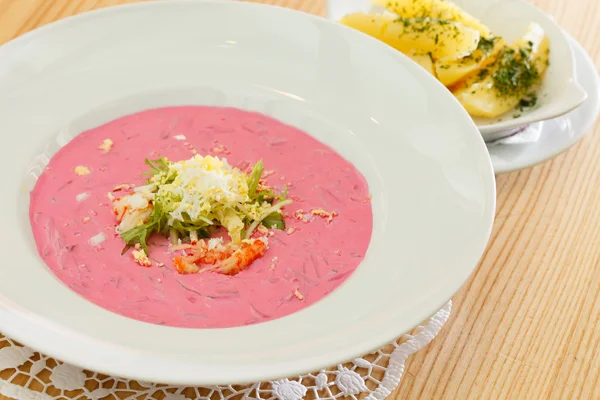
[435,38,505,86]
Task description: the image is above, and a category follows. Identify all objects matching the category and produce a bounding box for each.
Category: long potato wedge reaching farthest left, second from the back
[340,13,479,60]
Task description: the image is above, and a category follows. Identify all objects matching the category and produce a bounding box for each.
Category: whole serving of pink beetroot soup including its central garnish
[30,106,372,328]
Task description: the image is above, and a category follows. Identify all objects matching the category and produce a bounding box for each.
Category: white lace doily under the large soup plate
[0,302,452,400]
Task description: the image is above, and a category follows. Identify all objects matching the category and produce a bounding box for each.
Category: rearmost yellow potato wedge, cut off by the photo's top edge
[373,0,492,38]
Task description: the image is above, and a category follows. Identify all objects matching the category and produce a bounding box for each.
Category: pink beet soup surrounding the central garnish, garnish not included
[30,106,372,328]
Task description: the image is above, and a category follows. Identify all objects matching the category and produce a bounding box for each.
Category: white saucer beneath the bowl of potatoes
[487,36,600,174]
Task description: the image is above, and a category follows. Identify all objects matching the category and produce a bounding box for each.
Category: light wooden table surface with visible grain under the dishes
[0,0,600,399]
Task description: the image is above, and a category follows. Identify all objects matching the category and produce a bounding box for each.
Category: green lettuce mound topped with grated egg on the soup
[120,155,291,254]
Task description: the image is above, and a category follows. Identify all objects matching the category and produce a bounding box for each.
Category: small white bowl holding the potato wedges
[327,0,587,141]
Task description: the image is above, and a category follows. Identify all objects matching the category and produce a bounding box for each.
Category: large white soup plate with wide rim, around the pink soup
[0,0,495,385]
